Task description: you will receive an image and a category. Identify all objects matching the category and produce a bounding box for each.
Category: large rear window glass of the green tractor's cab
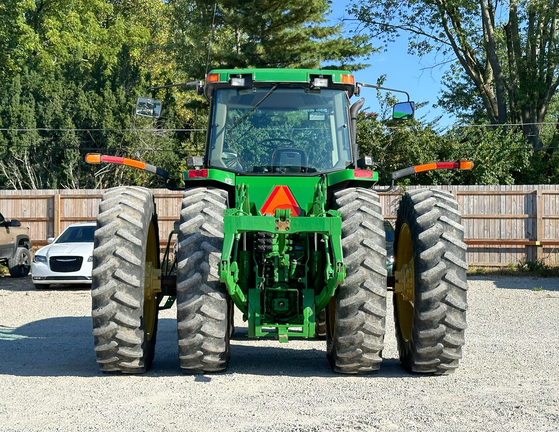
[209,86,351,174]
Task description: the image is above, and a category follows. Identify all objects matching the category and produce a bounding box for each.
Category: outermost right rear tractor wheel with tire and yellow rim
[393,189,468,375]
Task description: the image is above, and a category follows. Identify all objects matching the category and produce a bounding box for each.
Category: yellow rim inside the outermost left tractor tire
[144,222,161,341]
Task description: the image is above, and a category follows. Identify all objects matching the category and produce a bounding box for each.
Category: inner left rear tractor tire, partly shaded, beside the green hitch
[177,187,233,373]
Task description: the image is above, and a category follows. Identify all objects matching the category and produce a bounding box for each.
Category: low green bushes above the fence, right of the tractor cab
[357,82,532,185]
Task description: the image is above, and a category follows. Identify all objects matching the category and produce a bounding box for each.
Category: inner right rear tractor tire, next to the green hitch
[326,188,387,374]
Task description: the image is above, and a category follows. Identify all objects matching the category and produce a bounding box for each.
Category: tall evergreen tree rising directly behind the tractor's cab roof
[170,0,373,79]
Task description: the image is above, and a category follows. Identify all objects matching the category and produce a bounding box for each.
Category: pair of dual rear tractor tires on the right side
[326,188,468,375]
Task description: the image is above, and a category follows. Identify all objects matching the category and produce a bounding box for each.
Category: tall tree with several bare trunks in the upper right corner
[351,0,559,158]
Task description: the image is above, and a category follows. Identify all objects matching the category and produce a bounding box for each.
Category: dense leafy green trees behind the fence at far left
[0,0,188,188]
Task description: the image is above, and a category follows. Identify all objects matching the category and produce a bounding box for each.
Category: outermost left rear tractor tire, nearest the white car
[91,186,159,373]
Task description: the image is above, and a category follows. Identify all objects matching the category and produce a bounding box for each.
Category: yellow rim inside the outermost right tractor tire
[394,224,415,342]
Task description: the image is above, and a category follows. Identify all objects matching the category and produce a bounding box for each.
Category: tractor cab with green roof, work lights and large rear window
[205,70,354,175]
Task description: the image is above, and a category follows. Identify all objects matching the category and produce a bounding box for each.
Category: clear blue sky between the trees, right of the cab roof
[330,0,455,128]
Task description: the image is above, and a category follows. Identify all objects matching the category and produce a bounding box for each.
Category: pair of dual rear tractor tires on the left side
[92,187,232,373]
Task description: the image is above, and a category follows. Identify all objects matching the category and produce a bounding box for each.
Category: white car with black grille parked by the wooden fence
[31,222,96,288]
